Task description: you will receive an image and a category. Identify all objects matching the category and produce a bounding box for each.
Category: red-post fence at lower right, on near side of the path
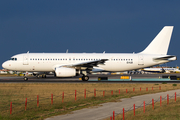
[110,92,180,120]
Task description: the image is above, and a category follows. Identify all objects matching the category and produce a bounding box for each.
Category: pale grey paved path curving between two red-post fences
[45,90,180,120]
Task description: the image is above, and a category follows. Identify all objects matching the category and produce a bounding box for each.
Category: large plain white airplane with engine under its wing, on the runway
[2,26,176,81]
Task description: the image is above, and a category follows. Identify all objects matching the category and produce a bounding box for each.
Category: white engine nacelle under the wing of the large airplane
[55,67,76,77]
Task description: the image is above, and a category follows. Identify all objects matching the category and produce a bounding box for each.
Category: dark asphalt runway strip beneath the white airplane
[0,74,180,83]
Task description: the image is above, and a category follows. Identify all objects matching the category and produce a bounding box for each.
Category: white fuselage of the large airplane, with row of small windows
[2,53,173,72]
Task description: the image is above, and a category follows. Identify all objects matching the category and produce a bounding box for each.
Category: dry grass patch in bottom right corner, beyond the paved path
[111,98,180,120]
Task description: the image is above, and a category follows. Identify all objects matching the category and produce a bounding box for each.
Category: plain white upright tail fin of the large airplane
[141,26,174,55]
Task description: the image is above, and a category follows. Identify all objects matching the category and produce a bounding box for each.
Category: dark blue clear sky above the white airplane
[0,0,180,68]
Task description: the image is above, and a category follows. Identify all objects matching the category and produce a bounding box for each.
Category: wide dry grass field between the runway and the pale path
[0,83,180,120]
